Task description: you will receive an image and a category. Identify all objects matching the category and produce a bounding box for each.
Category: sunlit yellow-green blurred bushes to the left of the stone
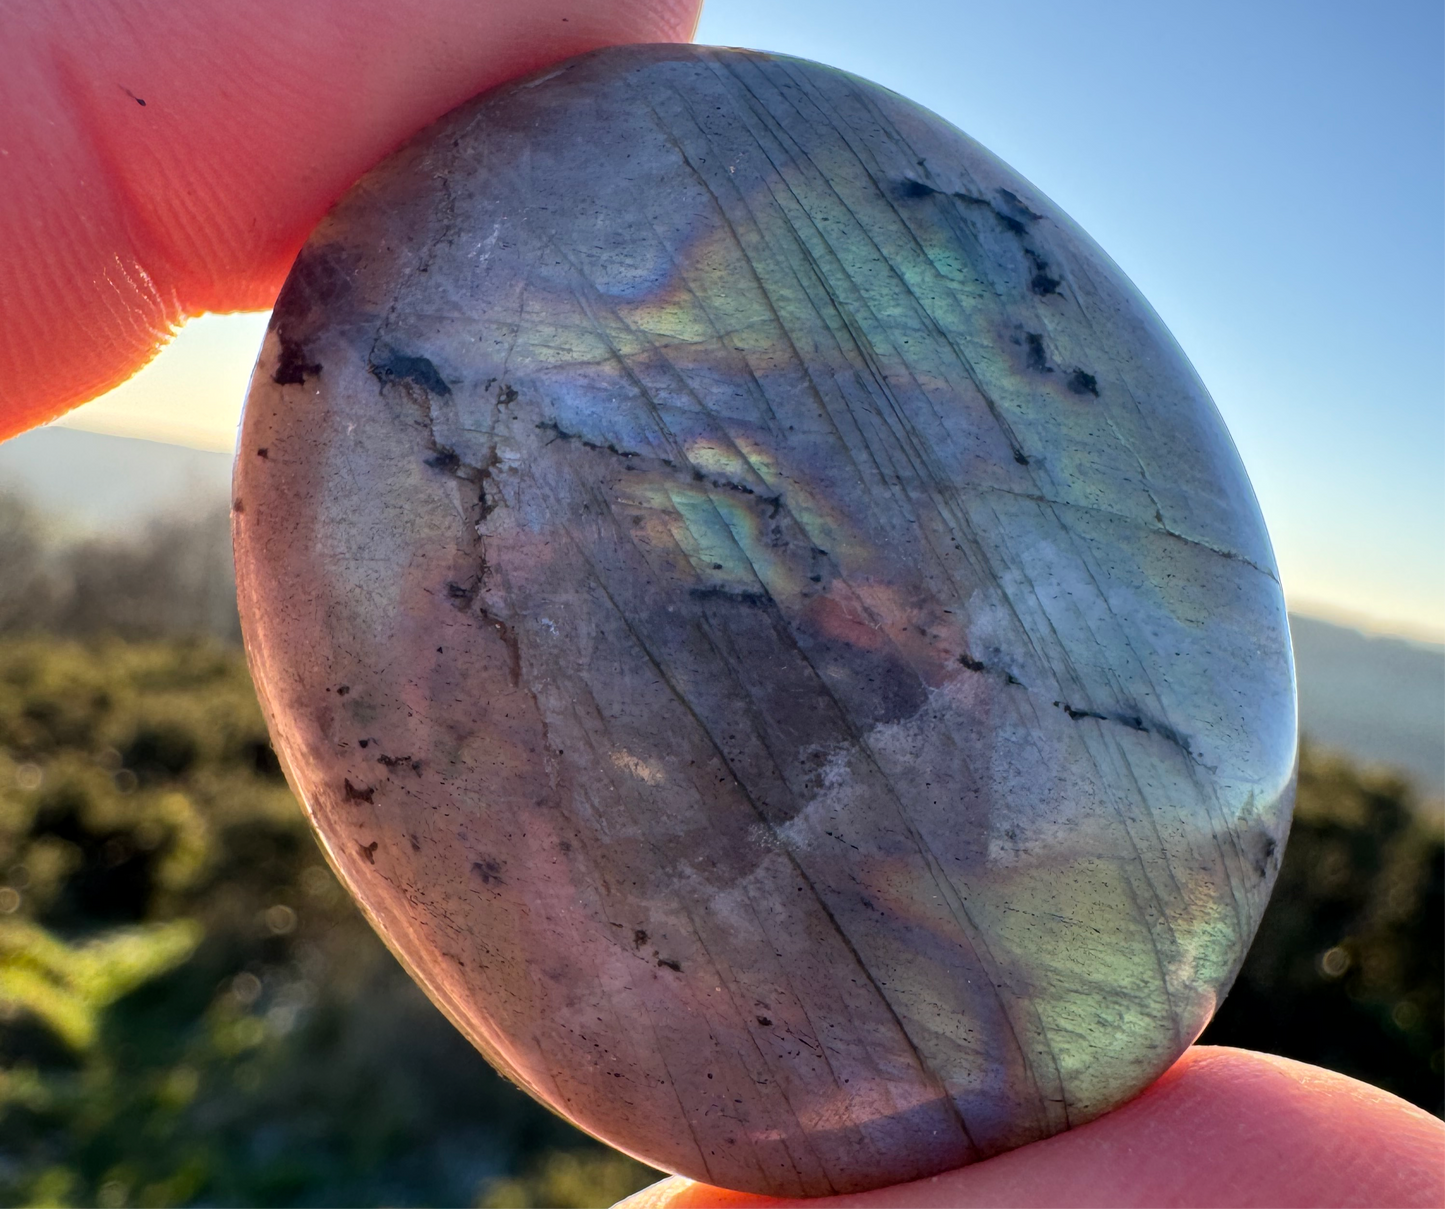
[0,638,647,1209]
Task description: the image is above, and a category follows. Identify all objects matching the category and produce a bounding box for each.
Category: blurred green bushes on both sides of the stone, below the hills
[0,624,1445,1209]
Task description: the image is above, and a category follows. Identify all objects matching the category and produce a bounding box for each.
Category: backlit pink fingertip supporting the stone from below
[618,1047,1445,1209]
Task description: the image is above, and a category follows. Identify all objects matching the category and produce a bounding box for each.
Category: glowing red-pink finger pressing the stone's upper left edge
[0,0,701,438]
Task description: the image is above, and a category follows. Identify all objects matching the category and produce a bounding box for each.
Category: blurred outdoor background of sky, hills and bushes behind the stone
[0,0,1445,1209]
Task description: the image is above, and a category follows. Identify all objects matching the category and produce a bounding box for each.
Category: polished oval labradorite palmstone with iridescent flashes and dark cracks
[236,46,1295,1196]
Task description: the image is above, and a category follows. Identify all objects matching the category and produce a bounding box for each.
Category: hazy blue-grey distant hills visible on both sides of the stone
[0,428,1445,799]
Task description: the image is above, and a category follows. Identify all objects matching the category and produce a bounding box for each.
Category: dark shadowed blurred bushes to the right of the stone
[1202,745,1445,1117]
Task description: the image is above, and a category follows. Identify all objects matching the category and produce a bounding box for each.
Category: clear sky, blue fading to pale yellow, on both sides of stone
[53,0,1445,638]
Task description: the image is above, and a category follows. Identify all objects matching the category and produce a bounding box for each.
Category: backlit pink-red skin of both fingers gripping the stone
[0,0,1445,1209]
